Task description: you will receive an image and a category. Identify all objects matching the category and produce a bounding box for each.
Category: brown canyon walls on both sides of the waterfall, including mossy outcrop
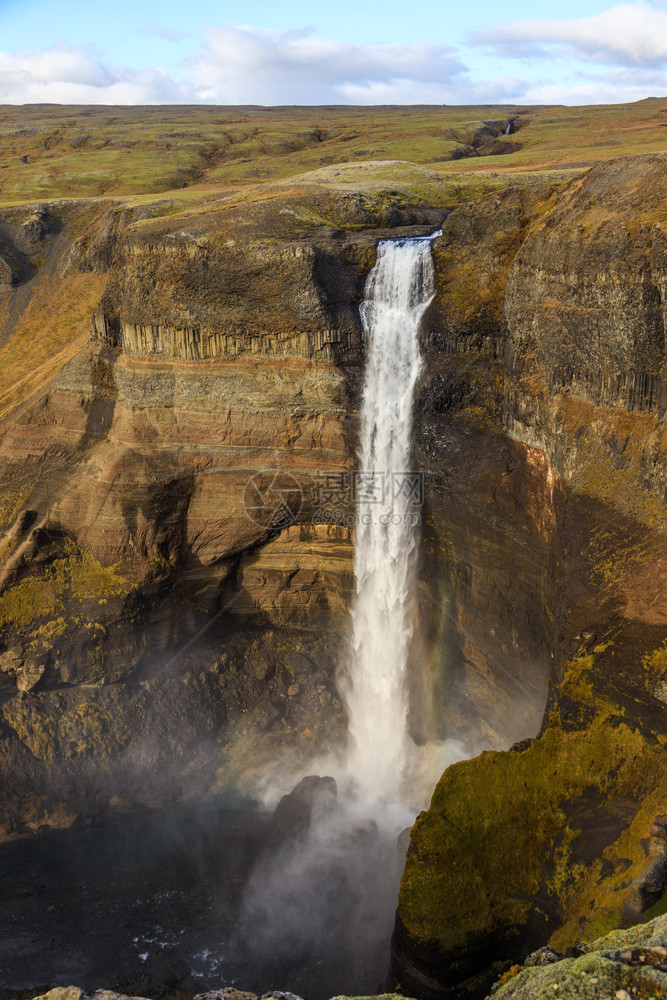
[0,101,667,1000]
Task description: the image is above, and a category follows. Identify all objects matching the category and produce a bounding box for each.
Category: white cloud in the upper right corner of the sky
[470,0,667,66]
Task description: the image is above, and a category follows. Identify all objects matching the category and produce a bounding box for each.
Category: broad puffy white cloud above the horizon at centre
[184,26,464,104]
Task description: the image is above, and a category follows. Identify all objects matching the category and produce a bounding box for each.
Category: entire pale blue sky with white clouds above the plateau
[0,0,667,105]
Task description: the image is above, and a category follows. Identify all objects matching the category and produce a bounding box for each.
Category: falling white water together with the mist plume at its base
[244,239,465,996]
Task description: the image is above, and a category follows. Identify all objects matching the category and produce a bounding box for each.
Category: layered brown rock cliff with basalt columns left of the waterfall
[0,178,442,835]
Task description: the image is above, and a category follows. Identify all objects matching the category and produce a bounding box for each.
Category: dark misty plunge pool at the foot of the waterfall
[0,798,405,1000]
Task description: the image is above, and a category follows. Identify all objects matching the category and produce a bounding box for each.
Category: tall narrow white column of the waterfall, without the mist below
[341,234,439,802]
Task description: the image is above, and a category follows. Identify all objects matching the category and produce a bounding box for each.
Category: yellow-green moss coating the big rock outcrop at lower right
[400,656,667,952]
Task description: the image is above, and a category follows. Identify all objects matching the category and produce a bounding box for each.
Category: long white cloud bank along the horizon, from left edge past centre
[0,25,465,104]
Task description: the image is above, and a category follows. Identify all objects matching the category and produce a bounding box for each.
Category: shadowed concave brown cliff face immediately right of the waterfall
[418,422,557,752]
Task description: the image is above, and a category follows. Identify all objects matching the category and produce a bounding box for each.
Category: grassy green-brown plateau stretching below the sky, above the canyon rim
[0,99,667,204]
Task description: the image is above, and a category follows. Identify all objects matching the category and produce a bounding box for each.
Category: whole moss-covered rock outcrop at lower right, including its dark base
[394,650,667,996]
